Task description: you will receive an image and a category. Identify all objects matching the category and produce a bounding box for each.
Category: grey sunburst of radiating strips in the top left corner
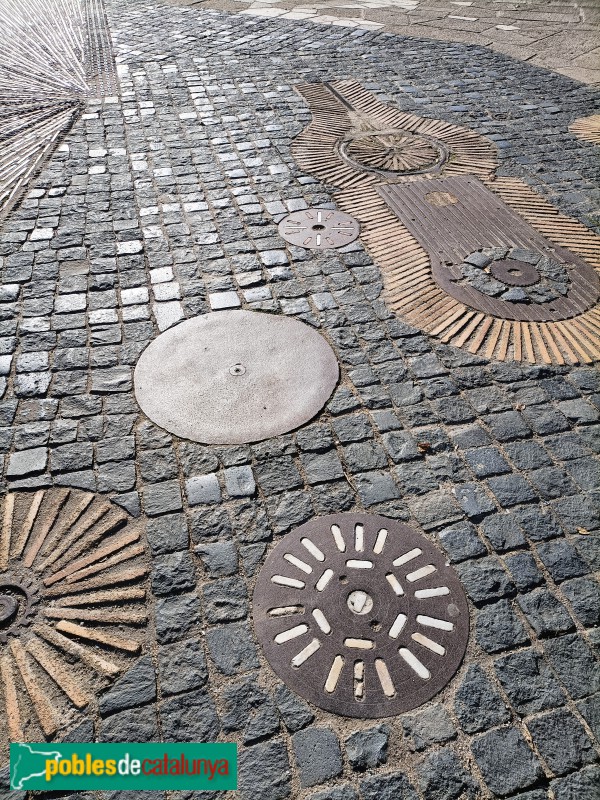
[0,0,118,222]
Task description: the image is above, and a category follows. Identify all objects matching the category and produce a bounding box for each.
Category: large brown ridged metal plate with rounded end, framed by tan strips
[377,176,600,322]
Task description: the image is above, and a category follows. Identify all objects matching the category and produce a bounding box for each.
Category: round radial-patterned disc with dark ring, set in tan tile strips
[340,130,447,175]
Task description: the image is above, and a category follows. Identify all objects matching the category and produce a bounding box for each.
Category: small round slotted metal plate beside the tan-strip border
[278,208,360,250]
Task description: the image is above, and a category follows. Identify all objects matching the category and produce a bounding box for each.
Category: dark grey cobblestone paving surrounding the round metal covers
[0,0,600,800]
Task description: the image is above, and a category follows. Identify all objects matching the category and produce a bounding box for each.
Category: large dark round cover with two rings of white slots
[253,513,469,718]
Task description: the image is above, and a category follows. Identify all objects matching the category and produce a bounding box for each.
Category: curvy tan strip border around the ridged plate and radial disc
[294,81,600,365]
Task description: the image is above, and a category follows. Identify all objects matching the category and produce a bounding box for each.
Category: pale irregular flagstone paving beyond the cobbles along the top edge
[169,0,600,83]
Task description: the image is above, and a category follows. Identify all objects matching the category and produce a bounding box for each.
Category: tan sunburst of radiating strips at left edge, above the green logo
[0,489,148,755]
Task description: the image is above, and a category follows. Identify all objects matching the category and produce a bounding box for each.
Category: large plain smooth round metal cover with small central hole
[134,311,339,444]
